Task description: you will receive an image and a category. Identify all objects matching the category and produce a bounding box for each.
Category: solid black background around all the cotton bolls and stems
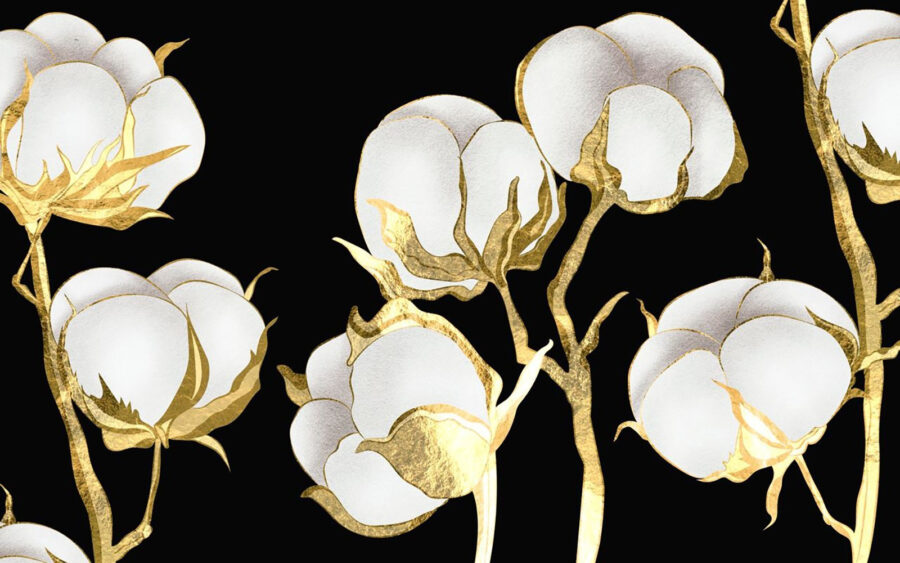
[0,0,900,562]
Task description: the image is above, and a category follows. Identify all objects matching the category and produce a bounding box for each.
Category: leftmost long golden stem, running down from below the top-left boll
[29,233,115,563]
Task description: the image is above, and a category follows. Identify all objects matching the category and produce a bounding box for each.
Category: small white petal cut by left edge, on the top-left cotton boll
[0,29,53,115]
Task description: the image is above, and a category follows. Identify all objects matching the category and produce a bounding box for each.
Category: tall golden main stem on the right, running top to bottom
[790,0,884,563]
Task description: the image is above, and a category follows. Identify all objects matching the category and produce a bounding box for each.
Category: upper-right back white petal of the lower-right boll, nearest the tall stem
[737,280,859,340]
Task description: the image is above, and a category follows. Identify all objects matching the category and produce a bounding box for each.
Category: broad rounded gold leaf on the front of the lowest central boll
[356,405,490,499]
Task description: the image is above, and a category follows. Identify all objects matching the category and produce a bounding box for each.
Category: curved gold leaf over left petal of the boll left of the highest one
[369,199,481,282]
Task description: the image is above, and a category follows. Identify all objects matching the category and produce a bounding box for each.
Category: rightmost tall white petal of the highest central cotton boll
[667,67,737,197]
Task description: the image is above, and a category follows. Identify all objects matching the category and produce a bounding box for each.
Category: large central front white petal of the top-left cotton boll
[16,62,125,184]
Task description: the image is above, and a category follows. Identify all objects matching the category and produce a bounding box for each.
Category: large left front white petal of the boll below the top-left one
[66,295,188,424]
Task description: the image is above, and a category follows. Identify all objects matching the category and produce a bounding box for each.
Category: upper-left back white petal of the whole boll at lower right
[658,278,762,342]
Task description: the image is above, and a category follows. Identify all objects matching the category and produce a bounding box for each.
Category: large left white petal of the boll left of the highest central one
[356,117,474,289]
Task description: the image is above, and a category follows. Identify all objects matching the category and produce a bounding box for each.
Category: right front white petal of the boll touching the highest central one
[462,121,556,249]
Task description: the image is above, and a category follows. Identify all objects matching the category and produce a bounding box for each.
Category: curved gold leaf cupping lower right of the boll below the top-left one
[166,319,278,440]
